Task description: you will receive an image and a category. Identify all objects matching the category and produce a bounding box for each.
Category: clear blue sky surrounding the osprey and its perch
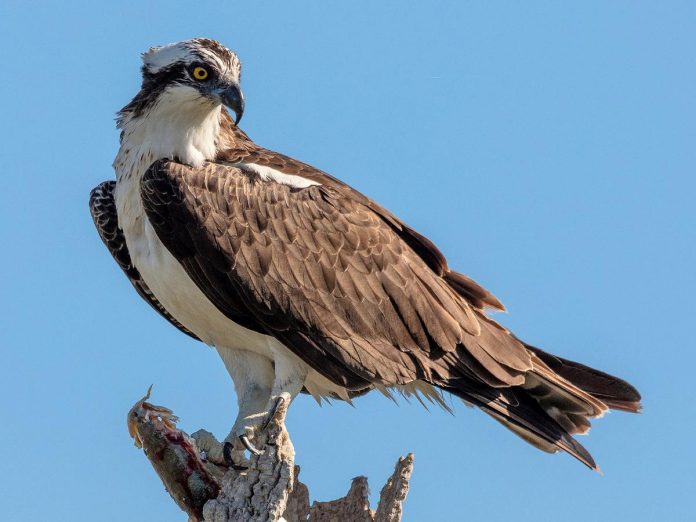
[0,0,696,522]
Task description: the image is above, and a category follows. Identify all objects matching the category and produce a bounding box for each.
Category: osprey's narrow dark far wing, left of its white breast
[89,181,199,340]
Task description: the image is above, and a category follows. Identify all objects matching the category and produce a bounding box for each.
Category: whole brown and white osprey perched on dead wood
[90,38,640,469]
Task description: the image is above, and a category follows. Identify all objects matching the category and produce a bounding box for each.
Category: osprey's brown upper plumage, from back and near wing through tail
[136,123,639,468]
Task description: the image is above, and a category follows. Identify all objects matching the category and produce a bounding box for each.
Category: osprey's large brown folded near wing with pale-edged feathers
[141,160,532,389]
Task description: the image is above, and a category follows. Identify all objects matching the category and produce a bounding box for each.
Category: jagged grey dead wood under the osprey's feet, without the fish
[130,390,413,522]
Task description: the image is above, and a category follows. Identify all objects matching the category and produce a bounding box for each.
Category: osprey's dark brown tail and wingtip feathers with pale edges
[440,344,641,470]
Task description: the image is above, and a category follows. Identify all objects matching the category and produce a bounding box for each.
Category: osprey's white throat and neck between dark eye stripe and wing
[114,86,222,176]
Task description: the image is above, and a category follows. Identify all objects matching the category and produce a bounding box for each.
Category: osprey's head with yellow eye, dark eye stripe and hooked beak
[121,38,244,123]
